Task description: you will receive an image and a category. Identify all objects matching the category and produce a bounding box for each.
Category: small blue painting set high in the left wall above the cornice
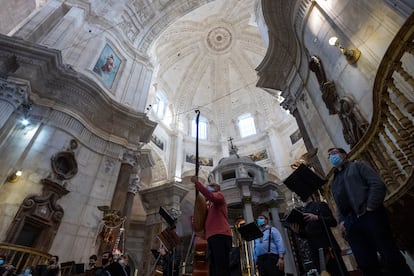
[93,44,121,88]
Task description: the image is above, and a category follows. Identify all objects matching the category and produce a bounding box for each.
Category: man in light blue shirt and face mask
[253,215,286,276]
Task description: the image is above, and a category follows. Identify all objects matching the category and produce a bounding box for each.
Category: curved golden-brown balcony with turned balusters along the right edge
[330,11,414,252]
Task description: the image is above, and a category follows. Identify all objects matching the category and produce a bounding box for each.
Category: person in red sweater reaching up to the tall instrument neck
[191,176,232,276]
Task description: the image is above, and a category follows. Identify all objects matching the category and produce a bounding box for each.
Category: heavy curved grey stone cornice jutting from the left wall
[0,35,156,149]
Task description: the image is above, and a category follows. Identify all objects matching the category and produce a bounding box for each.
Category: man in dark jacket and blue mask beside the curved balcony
[328,148,413,276]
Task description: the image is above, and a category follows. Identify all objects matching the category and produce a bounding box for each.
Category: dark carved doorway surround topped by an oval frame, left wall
[5,140,78,252]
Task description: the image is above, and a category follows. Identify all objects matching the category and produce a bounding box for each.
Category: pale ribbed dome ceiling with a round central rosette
[151,0,288,140]
